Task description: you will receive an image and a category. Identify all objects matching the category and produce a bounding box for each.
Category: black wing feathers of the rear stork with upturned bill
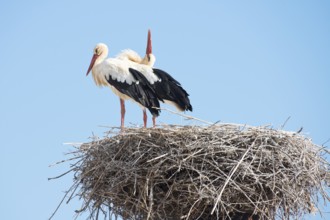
[153,69,192,111]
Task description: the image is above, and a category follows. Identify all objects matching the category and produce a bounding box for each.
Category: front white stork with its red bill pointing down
[86,43,162,129]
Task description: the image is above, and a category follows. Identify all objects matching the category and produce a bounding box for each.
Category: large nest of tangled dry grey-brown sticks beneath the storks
[51,124,330,219]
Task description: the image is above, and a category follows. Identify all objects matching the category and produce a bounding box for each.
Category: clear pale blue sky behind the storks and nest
[0,0,330,220]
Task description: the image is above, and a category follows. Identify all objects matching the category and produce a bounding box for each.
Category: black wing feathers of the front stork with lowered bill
[106,68,160,116]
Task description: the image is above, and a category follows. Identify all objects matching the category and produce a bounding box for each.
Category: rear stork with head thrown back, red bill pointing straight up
[117,30,192,120]
